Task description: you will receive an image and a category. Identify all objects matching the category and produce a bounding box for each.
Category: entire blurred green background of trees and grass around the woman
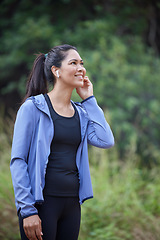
[0,0,160,240]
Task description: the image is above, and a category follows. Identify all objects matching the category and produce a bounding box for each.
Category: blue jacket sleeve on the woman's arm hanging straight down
[10,100,37,217]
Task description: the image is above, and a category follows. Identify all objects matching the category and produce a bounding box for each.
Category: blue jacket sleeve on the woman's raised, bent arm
[82,96,114,148]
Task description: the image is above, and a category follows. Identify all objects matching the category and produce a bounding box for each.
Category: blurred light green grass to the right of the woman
[80,149,160,240]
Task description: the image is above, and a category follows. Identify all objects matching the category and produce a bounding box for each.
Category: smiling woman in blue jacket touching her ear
[10,45,114,240]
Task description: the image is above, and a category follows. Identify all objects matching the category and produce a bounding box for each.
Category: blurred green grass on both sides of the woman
[0,115,160,240]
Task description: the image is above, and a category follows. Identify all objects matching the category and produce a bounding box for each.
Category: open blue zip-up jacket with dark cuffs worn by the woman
[10,94,114,217]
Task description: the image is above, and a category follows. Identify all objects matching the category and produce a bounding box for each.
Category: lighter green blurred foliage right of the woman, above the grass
[64,19,160,167]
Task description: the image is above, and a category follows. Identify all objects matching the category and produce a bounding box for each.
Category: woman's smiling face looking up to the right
[58,49,86,88]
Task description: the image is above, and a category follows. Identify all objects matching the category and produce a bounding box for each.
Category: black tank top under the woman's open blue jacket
[44,94,81,197]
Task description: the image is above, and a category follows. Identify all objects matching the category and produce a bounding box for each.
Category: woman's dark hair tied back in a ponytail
[24,44,77,101]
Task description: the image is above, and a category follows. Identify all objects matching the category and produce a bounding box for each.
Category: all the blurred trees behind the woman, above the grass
[0,0,160,166]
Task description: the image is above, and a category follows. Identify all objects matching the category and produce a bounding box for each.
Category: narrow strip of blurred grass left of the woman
[0,112,19,240]
